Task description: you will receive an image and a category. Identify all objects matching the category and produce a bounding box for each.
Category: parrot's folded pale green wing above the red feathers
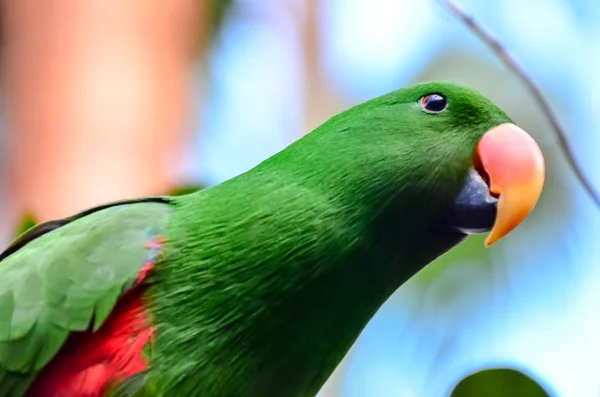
[0,197,173,397]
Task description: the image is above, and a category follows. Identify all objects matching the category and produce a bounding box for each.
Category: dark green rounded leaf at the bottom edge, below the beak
[451,368,550,397]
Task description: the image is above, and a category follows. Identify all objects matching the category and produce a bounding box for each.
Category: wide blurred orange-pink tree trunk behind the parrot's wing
[2,0,203,220]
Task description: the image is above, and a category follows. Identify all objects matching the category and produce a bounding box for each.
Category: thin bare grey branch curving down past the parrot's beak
[437,0,600,207]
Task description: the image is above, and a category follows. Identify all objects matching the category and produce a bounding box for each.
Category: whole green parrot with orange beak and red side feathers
[0,82,545,397]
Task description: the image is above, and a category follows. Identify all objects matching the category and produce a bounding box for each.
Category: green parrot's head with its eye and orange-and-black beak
[274,82,545,246]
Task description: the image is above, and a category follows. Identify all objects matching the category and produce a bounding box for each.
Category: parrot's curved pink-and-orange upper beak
[476,123,545,247]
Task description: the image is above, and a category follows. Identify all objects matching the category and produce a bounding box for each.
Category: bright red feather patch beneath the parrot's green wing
[25,235,162,397]
